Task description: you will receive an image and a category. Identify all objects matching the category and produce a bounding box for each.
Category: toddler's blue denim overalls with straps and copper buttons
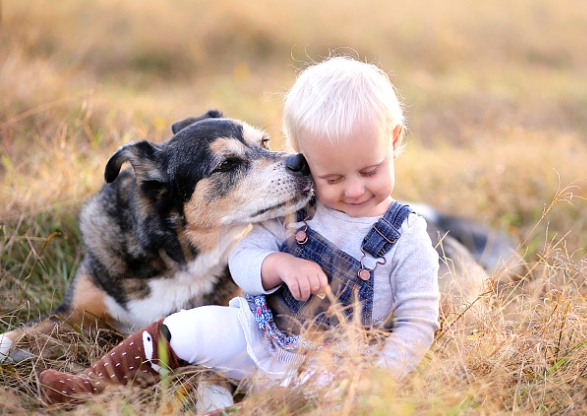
[245,201,411,350]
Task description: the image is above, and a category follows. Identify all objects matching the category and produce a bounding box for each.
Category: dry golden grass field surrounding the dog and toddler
[0,0,587,416]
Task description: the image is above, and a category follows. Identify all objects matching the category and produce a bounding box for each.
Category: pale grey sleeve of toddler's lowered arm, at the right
[375,214,440,380]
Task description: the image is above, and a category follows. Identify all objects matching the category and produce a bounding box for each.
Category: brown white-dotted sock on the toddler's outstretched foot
[39,319,187,404]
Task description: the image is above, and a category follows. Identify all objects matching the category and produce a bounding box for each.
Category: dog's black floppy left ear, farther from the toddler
[104,140,167,199]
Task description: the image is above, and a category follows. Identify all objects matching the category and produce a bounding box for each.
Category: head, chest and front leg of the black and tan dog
[0,111,313,361]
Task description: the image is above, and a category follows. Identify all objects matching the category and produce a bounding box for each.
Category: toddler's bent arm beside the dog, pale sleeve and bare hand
[228,220,328,300]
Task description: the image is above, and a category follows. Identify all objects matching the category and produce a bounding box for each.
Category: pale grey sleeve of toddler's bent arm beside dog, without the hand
[228,219,285,295]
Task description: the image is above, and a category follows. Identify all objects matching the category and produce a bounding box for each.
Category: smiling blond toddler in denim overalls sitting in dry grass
[40,57,440,402]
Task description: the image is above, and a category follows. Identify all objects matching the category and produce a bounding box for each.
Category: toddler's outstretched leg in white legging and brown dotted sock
[39,306,255,403]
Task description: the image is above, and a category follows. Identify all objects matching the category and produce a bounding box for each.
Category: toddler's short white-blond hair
[283,56,405,151]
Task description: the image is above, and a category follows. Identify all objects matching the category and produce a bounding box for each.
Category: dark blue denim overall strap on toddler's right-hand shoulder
[362,201,412,257]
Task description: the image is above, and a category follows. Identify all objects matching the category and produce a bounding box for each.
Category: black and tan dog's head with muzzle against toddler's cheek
[104,111,313,255]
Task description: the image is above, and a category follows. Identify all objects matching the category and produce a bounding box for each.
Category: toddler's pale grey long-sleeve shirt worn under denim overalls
[229,203,440,379]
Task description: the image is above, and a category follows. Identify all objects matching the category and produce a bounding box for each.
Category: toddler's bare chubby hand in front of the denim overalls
[261,253,330,301]
